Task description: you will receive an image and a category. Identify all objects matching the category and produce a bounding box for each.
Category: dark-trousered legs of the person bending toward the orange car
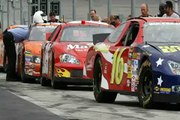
[3,32,16,80]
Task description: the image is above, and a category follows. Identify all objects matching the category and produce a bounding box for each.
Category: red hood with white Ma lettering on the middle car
[54,42,93,59]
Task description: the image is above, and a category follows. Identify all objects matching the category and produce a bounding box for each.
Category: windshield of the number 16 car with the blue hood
[143,22,180,43]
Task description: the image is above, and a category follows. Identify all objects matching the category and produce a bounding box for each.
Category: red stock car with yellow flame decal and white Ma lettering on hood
[40,20,115,88]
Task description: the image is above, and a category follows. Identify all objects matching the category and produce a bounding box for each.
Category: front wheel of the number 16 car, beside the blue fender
[138,60,154,108]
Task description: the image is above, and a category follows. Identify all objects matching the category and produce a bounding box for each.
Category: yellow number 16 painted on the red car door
[110,48,125,85]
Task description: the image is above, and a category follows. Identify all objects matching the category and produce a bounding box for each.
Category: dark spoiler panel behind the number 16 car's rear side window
[93,33,110,45]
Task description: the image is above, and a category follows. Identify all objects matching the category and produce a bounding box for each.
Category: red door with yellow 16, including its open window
[110,21,138,91]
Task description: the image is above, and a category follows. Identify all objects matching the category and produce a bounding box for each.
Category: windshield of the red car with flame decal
[60,26,114,42]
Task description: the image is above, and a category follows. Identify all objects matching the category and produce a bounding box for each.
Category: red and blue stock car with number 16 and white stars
[83,17,180,108]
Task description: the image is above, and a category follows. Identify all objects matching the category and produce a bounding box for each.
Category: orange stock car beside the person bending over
[16,23,60,82]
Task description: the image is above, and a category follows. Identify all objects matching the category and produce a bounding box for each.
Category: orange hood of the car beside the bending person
[24,41,42,56]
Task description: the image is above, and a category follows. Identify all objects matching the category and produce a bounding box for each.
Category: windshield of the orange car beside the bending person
[29,26,57,41]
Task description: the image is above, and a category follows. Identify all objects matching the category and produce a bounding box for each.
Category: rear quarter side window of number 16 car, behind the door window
[108,23,126,43]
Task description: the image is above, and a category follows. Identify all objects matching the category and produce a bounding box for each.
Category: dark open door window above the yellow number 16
[122,22,139,46]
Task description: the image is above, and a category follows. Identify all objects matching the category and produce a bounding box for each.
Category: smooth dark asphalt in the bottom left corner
[0,88,65,120]
